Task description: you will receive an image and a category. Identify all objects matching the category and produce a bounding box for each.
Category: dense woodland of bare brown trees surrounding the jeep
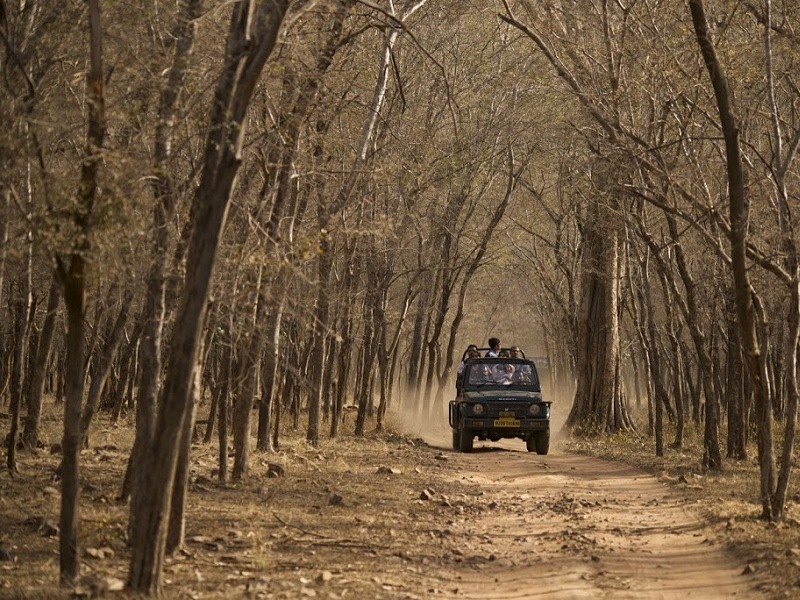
[0,0,800,593]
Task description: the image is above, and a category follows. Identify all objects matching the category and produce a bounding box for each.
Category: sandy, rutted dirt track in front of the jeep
[418,433,766,599]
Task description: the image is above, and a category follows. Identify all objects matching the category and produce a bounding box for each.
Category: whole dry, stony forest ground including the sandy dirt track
[0,406,800,599]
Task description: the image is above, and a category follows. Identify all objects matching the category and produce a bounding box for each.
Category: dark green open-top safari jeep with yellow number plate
[449,358,551,454]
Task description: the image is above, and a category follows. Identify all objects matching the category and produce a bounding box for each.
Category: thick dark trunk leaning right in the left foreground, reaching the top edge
[128,0,289,594]
